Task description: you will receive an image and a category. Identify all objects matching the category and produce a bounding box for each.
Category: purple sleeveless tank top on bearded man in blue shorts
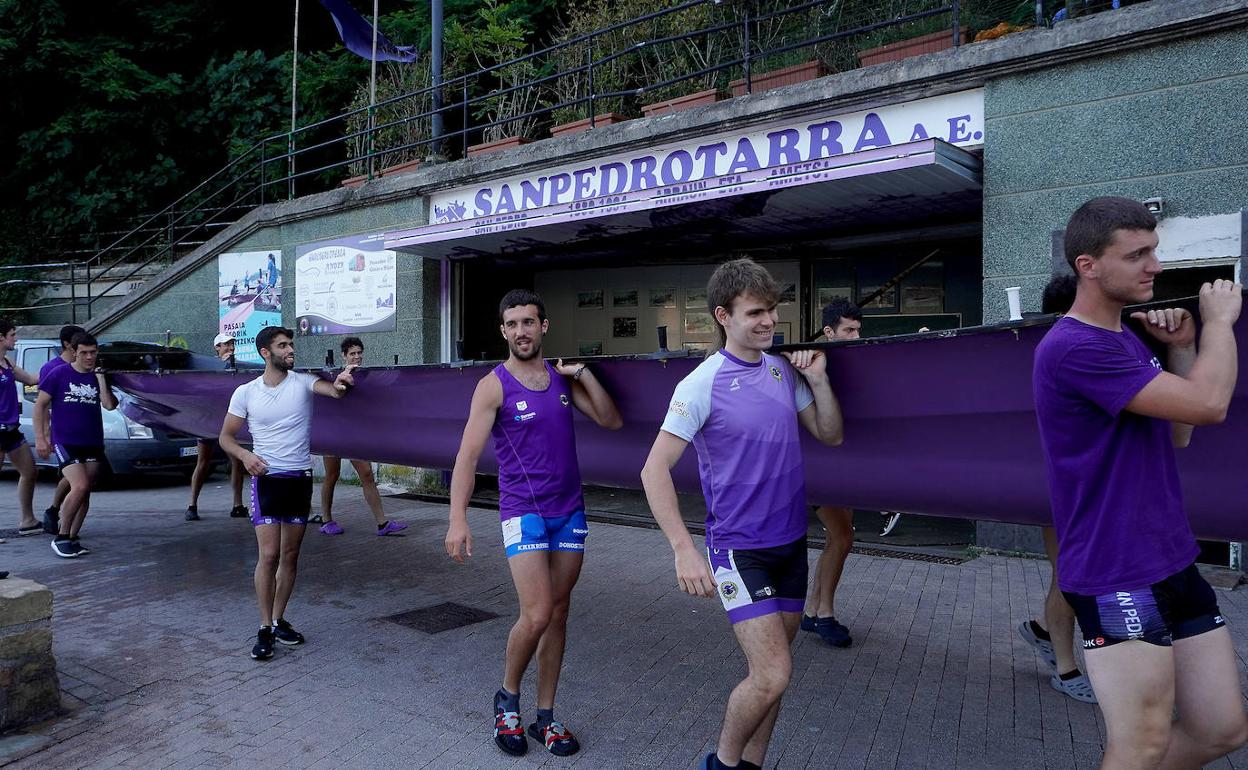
[490,363,585,520]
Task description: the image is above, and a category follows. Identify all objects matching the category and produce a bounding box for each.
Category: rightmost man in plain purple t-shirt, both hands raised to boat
[1032,197,1248,768]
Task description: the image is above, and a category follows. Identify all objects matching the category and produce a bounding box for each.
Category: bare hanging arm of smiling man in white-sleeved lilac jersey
[641,431,715,597]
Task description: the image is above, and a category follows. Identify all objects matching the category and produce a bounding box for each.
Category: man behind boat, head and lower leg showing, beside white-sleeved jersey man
[801,297,862,646]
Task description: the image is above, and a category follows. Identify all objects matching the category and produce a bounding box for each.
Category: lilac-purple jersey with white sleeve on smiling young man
[663,351,815,549]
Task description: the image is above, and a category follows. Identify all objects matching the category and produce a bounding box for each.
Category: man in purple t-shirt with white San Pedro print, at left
[35,332,117,559]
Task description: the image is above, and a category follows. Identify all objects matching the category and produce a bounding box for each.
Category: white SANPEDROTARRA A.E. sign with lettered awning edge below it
[387,89,983,247]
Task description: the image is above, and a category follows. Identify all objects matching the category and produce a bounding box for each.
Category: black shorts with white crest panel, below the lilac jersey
[706,535,806,623]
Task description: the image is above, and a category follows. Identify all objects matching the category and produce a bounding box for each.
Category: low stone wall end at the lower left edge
[0,578,60,733]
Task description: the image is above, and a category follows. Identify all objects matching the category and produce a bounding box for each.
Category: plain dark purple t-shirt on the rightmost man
[1032,316,1199,595]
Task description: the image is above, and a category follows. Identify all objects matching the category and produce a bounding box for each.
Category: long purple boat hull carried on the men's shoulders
[115,305,1248,540]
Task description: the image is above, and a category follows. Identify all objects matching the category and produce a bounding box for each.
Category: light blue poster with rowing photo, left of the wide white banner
[217,250,282,362]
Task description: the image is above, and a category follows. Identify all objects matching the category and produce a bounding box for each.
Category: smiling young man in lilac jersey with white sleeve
[641,260,842,770]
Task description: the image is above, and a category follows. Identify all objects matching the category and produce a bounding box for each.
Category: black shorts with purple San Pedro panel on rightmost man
[1062,563,1227,650]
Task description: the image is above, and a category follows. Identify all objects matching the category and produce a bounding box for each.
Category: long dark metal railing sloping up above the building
[53,0,1133,321]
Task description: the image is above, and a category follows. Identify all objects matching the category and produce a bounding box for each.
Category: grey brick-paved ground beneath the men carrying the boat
[0,479,1248,770]
